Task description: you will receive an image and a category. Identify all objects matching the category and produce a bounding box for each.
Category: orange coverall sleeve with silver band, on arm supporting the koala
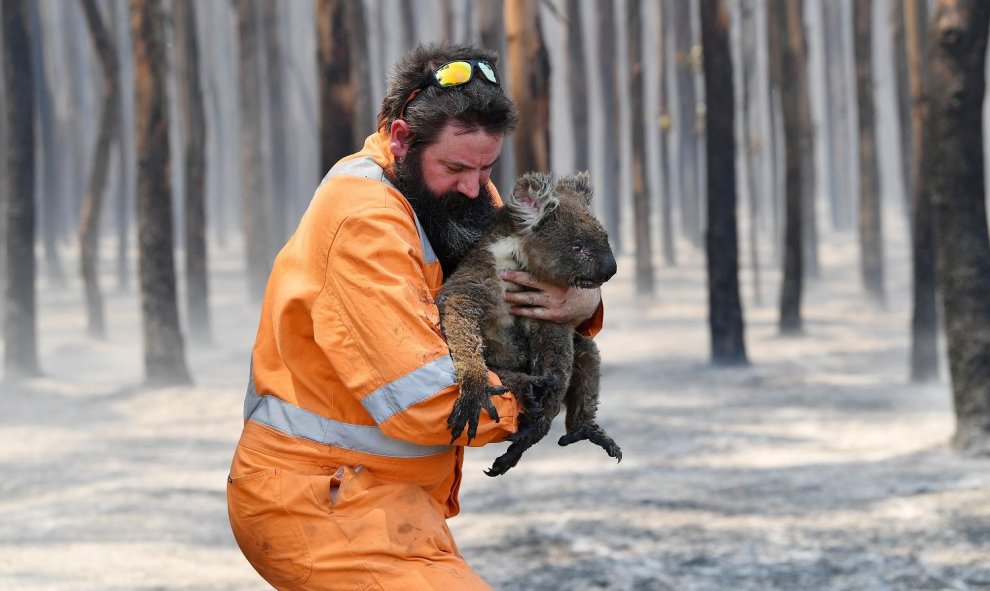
[313,207,519,446]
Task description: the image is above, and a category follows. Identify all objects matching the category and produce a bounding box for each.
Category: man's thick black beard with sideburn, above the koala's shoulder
[392,148,495,278]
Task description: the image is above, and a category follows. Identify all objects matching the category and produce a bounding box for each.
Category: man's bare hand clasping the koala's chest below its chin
[499,271,602,327]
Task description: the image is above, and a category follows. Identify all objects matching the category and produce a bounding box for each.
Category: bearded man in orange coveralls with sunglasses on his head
[227,45,601,591]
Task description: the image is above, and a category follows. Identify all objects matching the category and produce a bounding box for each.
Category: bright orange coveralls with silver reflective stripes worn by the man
[227,134,602,591]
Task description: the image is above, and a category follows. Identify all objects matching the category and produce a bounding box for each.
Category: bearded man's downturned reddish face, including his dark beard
[395,125,502,277]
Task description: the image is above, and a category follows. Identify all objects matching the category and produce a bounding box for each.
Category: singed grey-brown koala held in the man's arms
[437,172,622,476]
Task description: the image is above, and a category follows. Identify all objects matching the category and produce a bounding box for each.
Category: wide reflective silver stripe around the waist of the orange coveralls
[244,378,450,458]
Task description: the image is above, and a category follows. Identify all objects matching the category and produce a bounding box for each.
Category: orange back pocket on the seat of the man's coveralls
[227,468,312,585]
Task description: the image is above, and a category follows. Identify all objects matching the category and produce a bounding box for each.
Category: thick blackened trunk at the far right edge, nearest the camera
[924,0,990,454]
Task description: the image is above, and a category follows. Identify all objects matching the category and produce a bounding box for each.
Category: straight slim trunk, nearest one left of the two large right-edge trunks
[853,2,885,305]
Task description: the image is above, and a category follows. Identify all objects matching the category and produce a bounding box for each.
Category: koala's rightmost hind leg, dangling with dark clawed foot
[557,334,622,461]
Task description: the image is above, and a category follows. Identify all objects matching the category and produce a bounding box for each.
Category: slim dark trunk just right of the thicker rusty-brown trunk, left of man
[172,0,210,342]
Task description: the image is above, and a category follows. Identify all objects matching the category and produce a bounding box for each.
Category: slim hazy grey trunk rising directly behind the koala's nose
[595,2,623,252]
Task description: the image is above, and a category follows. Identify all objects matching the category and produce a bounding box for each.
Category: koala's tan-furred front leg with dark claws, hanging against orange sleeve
[437,288,506,443]
